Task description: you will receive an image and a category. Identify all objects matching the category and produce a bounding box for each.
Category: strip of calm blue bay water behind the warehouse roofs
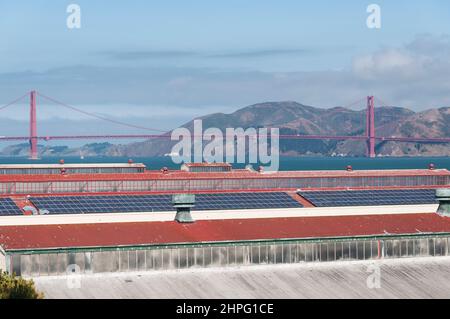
[0,157,450,171]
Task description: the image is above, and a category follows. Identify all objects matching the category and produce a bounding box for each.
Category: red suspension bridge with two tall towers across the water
[0,91,450,159]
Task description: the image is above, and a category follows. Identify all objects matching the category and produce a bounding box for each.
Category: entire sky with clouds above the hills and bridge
[0,0,450,140]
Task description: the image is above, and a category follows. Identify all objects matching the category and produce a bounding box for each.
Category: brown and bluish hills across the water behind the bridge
[0,101,450,156]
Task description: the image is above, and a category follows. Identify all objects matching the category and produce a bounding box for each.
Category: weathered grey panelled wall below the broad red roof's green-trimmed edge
[10,237,450,277]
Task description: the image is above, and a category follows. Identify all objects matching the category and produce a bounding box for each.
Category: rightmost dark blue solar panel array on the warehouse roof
[298,189,437,207]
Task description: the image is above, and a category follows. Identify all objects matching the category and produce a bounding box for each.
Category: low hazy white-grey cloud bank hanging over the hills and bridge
[0,35,450,123]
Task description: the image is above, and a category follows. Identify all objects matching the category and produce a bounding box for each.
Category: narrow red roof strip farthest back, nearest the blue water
[0,169,450,182]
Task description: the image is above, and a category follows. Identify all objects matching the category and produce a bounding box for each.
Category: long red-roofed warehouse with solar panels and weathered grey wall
[0,162,450,277]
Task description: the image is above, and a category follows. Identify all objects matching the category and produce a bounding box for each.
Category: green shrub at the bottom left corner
[0,271,44,299]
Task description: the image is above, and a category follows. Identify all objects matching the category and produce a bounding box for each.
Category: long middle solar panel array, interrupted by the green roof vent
[30,192,302,214]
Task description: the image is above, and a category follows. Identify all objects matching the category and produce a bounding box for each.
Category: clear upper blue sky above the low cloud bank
[0,0,450,72]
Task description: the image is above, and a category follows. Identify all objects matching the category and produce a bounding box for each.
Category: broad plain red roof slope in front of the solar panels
[0,213,450,250]
